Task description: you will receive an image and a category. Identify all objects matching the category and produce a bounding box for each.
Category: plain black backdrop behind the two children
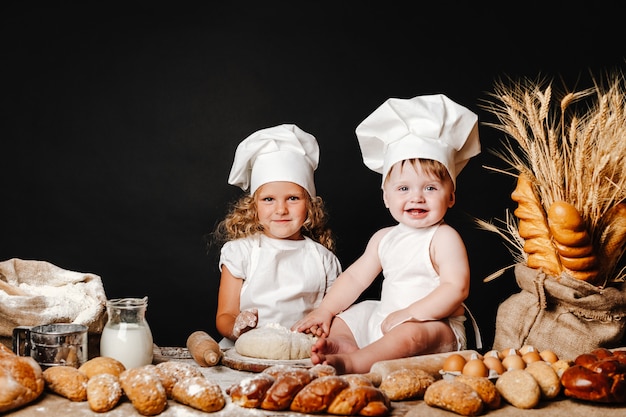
[0,1,626,347]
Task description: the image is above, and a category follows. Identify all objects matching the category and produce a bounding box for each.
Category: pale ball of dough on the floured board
[235,323,317,360]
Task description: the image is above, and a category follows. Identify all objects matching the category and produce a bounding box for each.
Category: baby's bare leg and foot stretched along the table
[312,321,456,374]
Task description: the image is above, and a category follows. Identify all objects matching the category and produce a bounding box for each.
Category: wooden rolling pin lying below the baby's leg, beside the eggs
[364,350,479,386]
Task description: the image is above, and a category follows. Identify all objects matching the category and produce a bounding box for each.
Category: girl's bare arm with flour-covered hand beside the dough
[215,265,258,340]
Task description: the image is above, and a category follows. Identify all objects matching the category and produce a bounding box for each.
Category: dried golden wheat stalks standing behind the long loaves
[477,72,626,282]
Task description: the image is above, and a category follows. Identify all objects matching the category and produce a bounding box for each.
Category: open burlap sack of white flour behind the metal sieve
[0,258,106,356]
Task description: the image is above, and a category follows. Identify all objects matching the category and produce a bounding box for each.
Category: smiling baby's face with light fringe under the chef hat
[383,162,455,228]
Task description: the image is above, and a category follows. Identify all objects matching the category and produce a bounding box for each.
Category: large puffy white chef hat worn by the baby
[356,94,480,187]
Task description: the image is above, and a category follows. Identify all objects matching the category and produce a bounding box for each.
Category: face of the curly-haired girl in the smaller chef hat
[255,181,309,240]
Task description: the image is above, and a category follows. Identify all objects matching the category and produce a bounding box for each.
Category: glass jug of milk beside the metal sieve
[100,297,152,369]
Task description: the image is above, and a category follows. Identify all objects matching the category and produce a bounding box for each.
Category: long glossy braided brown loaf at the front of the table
[226,367,391,416]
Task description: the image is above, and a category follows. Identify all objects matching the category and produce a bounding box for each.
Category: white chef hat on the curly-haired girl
[228,124,319,197]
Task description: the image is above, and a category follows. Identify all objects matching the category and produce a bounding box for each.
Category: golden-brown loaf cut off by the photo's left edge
[0,343,45,413]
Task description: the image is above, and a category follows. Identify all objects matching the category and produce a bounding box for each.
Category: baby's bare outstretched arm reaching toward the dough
[291,228,389,337]
